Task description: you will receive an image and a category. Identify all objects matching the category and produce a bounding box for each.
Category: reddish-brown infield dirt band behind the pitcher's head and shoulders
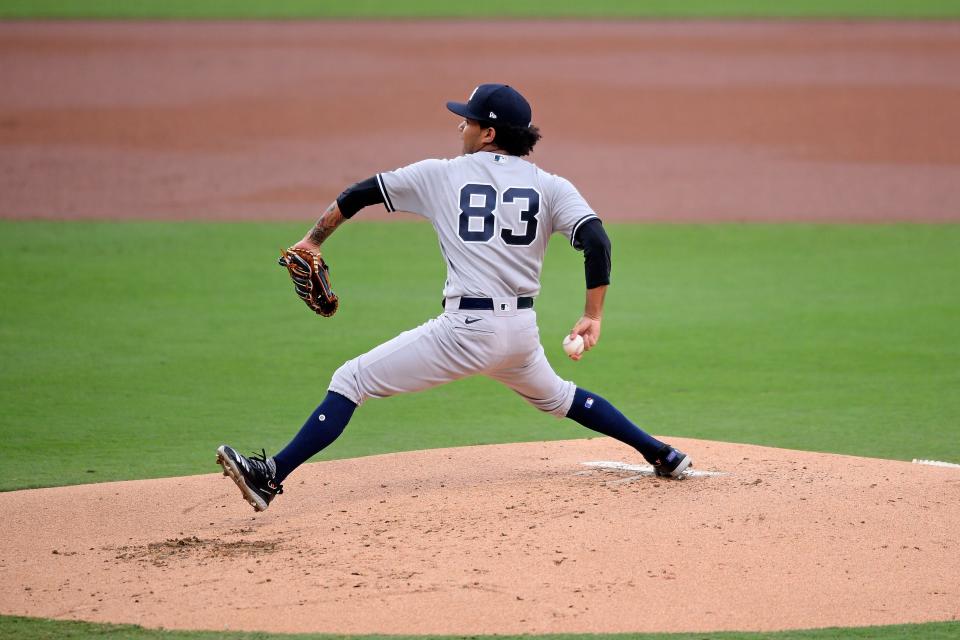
[0,21,960,221]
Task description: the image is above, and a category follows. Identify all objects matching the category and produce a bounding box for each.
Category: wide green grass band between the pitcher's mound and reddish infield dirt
[0,221,960,490]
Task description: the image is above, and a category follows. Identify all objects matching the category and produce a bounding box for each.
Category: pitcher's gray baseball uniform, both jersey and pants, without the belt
[329,151,597,417]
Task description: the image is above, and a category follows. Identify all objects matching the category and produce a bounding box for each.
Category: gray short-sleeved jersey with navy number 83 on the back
[377,151,597,298]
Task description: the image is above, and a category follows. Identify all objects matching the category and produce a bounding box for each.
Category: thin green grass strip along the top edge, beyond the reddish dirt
[0,0,960,19]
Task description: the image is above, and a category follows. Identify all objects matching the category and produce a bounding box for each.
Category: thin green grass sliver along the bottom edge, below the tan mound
[0,616,960,640]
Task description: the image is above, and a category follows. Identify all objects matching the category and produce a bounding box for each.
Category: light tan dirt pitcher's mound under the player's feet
[0,438,960,634]
